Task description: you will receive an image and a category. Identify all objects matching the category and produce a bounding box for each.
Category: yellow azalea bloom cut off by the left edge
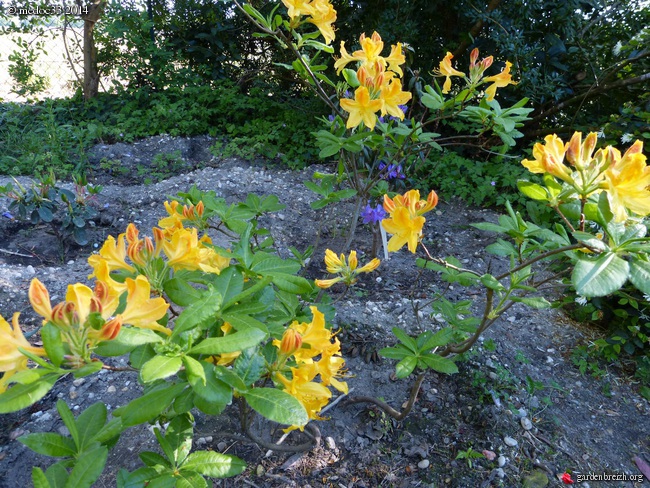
[0,312,46,393]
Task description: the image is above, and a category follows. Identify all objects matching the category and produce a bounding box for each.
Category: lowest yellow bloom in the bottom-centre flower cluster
[274,363,332,431]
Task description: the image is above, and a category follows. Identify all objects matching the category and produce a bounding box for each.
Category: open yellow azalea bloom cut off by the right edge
[604,141,650,222]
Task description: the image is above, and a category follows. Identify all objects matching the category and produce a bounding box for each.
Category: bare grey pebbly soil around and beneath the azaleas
[0,137,650,488]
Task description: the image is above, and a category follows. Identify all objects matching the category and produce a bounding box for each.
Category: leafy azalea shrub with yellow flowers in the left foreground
[0,188,352,486]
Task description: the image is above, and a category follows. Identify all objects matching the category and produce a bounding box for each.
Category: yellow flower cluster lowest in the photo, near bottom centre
[273,307,348,430]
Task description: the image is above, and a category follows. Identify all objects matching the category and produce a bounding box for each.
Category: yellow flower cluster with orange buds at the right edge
[521,132,650,222]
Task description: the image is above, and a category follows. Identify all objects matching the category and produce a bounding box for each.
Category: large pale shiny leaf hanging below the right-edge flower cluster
[571,252,630,297]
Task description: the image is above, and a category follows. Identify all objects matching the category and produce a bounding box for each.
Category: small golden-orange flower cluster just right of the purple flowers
[381,190,438,253]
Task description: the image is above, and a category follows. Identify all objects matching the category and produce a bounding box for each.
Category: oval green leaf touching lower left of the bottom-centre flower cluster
[243,388,309,427]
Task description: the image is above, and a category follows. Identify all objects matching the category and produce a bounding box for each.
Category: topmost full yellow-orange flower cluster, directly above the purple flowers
[334,32,411,130]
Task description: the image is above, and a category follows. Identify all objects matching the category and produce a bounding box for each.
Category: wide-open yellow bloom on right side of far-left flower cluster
[118,275,171,335]
